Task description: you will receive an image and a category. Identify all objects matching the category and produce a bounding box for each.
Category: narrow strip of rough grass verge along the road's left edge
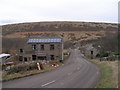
[0,50,69,81]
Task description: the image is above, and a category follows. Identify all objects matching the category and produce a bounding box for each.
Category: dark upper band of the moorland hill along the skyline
[2,22,118,35]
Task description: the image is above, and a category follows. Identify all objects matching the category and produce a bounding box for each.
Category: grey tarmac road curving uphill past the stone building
[2,49,100,88]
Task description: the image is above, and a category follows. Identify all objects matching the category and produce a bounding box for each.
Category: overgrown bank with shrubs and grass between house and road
[0,49,70,81]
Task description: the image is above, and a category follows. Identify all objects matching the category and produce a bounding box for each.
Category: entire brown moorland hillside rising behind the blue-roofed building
[2,22,118,52]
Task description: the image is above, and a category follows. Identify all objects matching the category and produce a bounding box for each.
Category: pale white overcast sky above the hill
[0,0,119,25]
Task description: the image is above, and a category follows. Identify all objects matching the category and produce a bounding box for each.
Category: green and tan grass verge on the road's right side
[90,59,118,88]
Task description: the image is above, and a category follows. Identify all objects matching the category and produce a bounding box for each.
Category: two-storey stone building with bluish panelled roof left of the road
[18,38,63,61]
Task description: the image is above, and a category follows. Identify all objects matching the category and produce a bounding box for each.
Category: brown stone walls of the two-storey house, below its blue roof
[18,43,62,61]
